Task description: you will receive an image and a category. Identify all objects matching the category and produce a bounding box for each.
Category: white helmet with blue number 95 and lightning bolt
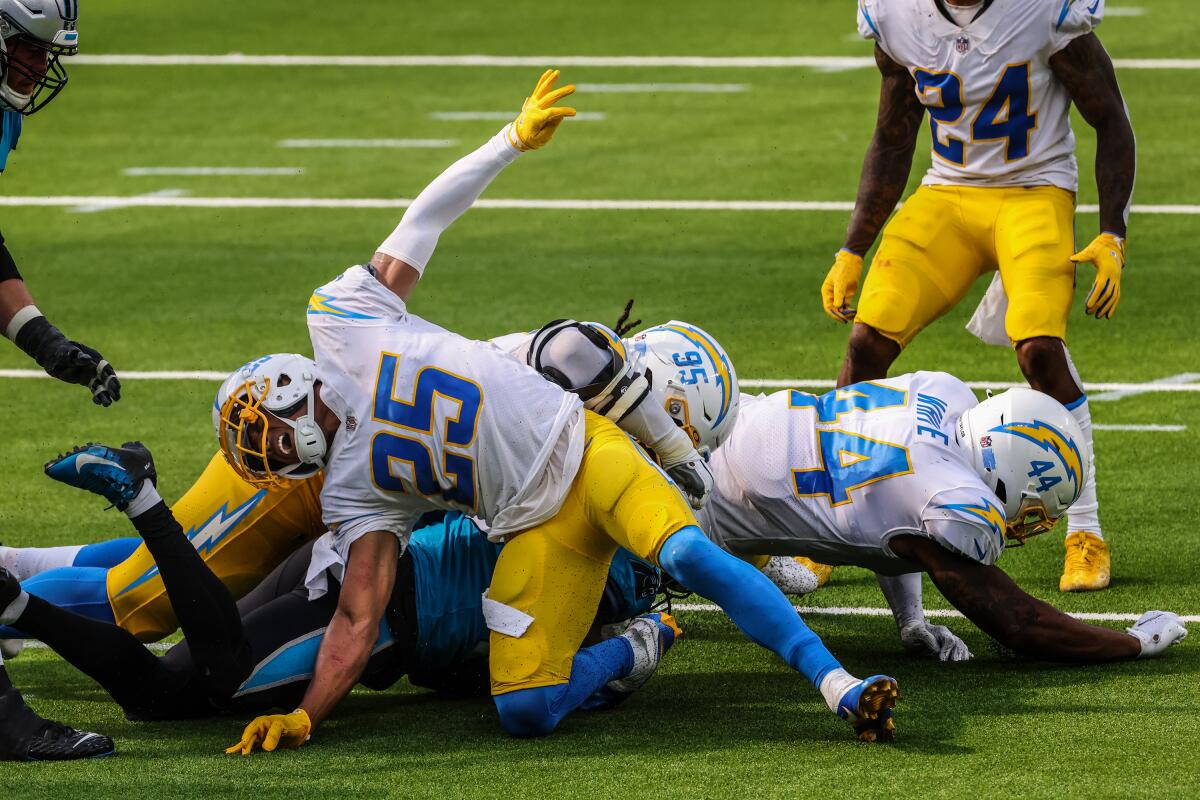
[628,320,740,455]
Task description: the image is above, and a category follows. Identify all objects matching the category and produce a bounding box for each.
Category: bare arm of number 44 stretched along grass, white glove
[889,535,1187,663]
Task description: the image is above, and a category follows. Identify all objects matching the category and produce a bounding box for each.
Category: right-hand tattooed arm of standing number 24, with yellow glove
[1050,34,1138,319]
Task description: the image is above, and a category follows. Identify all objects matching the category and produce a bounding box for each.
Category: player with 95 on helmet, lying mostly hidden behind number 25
[0,320,816,644]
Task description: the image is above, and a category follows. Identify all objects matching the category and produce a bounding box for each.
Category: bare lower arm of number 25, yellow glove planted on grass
[226,531,400,756]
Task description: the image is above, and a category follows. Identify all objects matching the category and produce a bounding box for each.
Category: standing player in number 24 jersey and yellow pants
[822,0,1135,591]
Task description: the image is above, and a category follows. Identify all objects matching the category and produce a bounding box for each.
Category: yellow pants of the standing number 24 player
[856,186,1075,347]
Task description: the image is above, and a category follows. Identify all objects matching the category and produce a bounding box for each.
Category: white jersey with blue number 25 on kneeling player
[300,266,583,559]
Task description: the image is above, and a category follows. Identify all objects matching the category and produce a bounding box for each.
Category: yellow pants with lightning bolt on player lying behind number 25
[108,453,325,642]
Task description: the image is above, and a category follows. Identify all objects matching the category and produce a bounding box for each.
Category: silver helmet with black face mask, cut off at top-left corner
[0,0,79,116]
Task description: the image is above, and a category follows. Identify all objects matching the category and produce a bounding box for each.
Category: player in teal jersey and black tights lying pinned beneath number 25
[0,443,673,752]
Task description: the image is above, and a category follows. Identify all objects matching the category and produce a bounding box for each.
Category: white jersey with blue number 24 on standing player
[858,0,1104,192]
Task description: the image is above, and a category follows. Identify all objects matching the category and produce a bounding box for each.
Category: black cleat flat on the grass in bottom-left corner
[0,687,116,762]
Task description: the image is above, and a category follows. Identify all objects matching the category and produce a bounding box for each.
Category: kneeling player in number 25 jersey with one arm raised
[214,71,898,752]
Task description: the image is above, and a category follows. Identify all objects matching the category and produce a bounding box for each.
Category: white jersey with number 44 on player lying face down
[700,372,1006,575]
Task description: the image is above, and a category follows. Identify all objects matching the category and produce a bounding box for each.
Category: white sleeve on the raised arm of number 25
[377,126,521,273]
